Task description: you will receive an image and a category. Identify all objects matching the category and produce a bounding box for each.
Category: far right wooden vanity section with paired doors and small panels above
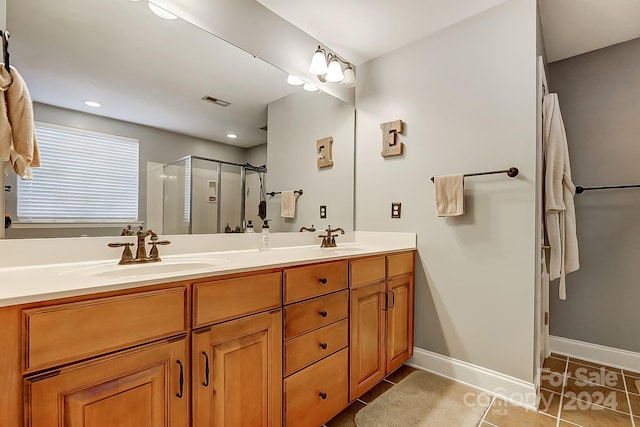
[349,252,414,401]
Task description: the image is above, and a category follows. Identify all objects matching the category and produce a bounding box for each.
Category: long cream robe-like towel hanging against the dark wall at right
[542,93,580,300]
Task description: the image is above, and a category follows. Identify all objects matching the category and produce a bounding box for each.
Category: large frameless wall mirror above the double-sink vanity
[4,0,355,238]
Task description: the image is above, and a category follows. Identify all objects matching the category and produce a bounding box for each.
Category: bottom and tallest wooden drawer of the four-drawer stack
[284,349,349,427]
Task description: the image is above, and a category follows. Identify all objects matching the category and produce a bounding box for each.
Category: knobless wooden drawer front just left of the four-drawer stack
[193,272,282,328]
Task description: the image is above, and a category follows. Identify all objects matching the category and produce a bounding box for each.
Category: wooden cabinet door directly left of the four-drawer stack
[193,310,282,427]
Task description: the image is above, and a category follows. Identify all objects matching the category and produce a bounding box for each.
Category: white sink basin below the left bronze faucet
[58,258,227,279]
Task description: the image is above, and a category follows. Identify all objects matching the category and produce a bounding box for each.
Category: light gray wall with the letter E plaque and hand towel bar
[356,0,536,382]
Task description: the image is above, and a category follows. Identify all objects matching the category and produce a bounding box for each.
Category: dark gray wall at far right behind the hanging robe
[549,39,640,352]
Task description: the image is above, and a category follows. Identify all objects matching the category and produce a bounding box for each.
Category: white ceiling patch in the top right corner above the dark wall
[538,0,640,62]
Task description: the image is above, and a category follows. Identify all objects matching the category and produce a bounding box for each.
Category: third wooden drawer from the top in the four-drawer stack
[284,319,349,376]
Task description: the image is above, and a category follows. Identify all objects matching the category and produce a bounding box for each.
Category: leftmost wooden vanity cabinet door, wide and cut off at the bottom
[25,337,189,427]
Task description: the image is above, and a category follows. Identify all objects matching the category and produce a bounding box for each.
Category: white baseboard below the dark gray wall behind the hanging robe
[549,336,640,372]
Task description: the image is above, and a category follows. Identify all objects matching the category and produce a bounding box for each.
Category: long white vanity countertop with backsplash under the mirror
[0,231,416,306]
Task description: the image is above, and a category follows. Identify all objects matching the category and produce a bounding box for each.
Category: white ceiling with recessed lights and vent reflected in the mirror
[7,0,302,147]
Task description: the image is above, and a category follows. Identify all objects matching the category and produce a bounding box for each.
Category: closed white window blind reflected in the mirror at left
[17,122,139,223]
